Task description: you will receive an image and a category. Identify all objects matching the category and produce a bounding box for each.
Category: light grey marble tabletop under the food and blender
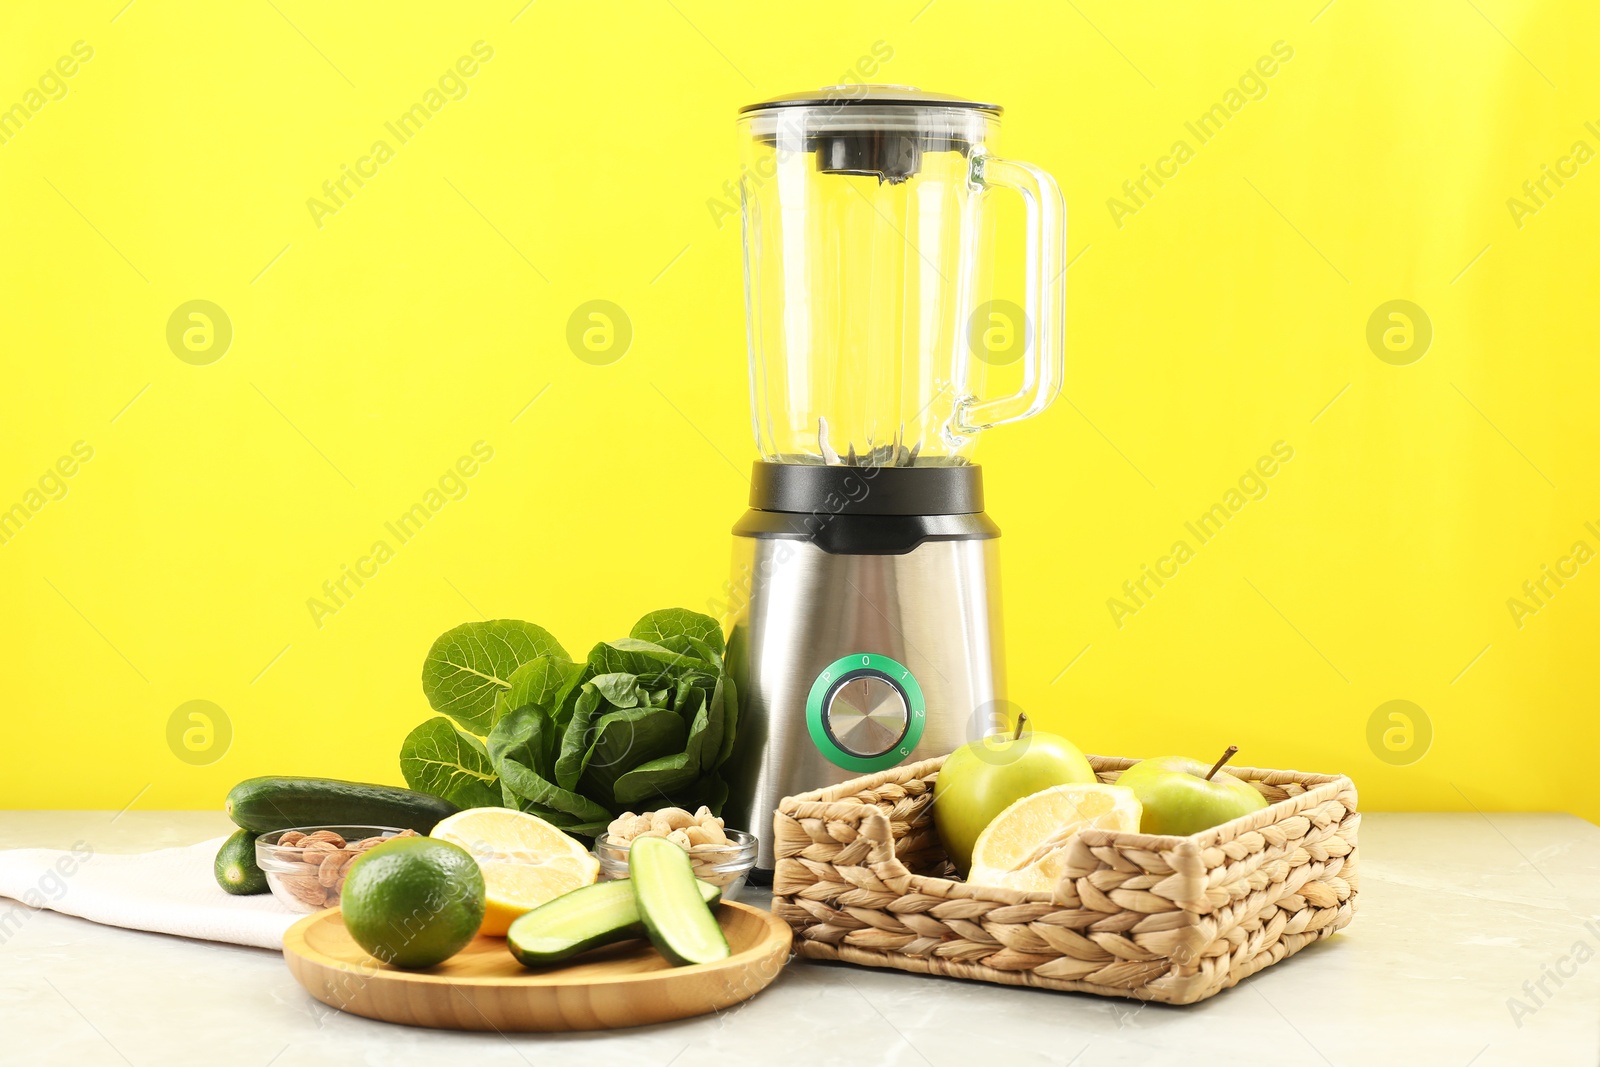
[0,811,1600,1067]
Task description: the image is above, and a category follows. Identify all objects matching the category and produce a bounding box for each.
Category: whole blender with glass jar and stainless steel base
[726,85,1066,880]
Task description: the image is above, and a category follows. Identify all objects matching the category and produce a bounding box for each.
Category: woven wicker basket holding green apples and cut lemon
[773,757,1362,1005]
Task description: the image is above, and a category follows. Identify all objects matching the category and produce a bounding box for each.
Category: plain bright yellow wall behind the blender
[0,0,1600,833]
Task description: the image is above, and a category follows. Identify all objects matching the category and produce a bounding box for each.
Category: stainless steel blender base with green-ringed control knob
[725,464,1002,878]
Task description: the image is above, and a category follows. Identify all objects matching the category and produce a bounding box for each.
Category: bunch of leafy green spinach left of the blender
[400,608,738,837]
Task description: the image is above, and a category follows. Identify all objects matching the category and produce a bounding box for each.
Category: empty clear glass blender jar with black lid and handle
[739,85,1066,467]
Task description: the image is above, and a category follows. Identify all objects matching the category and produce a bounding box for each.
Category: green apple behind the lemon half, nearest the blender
[933,715,1094,878]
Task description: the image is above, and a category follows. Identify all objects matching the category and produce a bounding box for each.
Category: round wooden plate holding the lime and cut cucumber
[283,901,790,1030]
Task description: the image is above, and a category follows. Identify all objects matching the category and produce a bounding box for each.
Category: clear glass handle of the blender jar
[955,155,1067,434]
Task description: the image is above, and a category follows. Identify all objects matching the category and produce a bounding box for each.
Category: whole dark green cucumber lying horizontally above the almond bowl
[226,776,459,833]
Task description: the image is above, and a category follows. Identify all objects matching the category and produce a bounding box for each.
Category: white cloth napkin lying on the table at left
[0,837,301,949]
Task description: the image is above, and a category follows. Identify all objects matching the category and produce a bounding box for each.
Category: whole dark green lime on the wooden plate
[339,837,483,968]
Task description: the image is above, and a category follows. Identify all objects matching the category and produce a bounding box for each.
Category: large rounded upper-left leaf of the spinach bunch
[422,619,566,734]
